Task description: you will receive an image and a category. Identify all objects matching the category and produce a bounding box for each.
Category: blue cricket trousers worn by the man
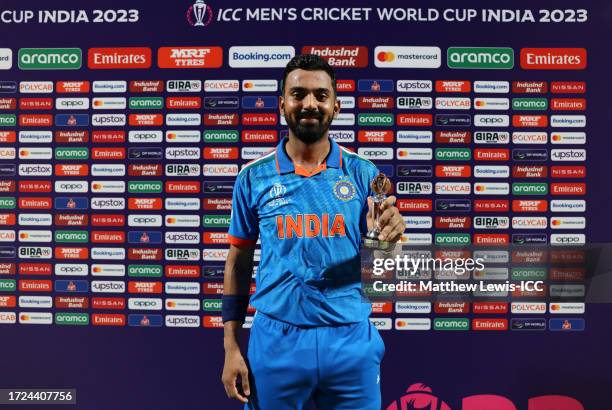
[245,312,385,410]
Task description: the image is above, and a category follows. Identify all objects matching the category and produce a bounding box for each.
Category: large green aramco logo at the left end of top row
[18,48,83,70]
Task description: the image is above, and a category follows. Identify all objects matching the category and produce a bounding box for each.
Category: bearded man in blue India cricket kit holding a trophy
[222,55,405,410]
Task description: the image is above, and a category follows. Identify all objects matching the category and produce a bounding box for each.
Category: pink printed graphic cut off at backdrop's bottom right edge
[386,383,584,410]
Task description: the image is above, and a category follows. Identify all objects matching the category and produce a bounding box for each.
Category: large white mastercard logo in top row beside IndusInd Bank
[374,46,442,68]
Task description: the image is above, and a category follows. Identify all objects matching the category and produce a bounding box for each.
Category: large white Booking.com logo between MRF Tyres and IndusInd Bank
[229,46,295,68]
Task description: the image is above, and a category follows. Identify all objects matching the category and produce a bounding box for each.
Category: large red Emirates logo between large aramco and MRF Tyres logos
[87,47,151,70]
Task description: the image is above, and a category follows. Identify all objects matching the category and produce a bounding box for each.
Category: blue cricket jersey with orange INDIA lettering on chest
[229,138,378,326]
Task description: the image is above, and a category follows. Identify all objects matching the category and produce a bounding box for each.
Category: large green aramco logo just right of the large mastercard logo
[447,47,514,70]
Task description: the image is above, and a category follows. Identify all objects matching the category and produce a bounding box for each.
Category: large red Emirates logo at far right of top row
[521,48,587,70]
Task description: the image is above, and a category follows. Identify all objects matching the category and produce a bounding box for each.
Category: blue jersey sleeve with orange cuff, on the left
[228,171,259,247]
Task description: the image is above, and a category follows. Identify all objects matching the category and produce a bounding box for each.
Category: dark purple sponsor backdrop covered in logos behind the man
[0,1,612,410]
